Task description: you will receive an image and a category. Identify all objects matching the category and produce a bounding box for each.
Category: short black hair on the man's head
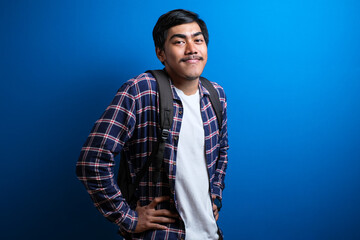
[153,9,209,50]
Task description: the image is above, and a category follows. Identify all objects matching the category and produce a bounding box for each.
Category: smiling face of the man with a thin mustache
[156,22,207,81]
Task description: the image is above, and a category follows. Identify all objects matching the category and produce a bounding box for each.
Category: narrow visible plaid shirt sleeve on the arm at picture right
[213,86,229,199]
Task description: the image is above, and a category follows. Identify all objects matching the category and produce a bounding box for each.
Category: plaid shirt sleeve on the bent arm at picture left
[76,83,138,232]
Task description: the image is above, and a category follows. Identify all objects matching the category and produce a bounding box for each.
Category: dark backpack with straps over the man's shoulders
[117,70,222,204]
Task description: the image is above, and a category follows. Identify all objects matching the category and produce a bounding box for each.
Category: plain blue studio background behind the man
[0,0,360,240]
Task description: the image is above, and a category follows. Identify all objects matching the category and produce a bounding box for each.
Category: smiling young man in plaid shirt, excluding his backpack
[76,9,228,240]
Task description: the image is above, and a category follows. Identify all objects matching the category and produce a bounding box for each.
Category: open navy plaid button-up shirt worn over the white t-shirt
[76,73,228,239]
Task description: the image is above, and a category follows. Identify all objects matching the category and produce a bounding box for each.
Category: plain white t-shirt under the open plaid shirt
[175,89,219,240]
